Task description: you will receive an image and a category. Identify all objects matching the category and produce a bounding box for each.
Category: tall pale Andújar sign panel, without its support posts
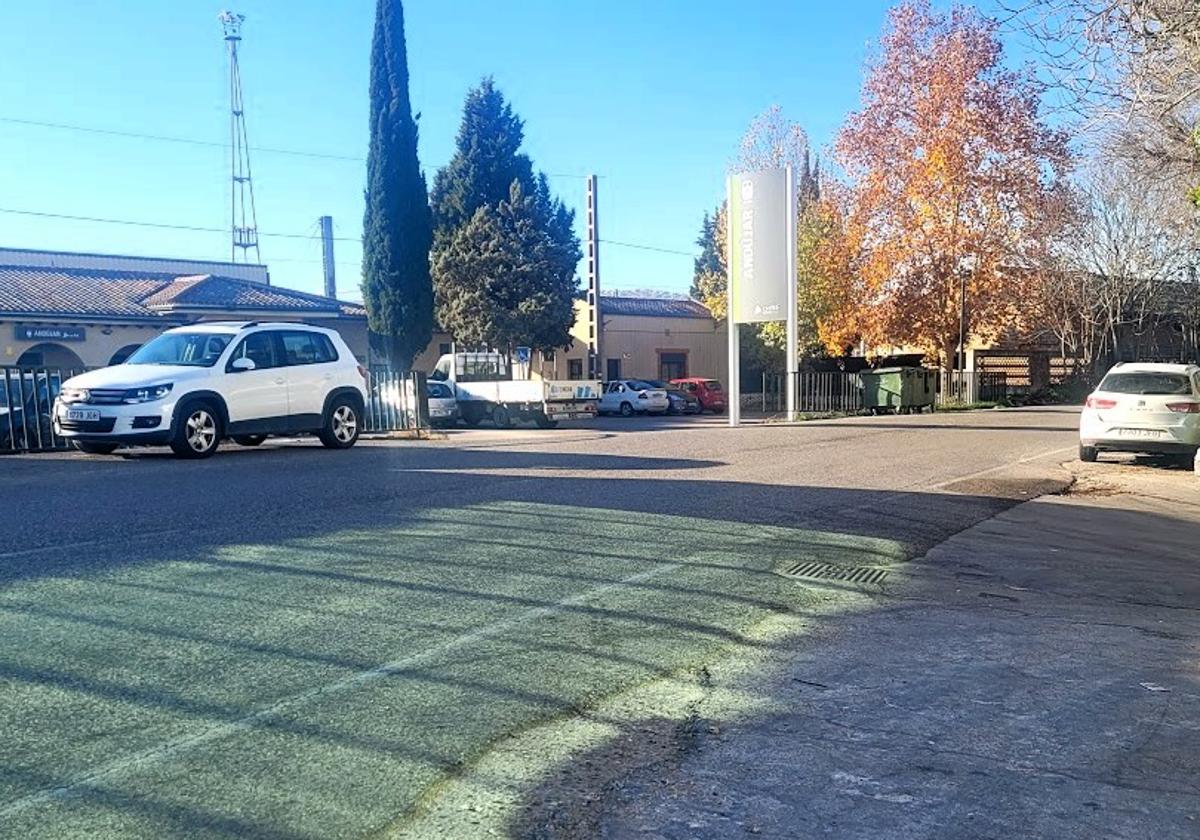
[728,169,794,324]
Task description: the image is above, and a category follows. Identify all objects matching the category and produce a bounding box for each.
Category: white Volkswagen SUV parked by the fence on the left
[54,322,366,458]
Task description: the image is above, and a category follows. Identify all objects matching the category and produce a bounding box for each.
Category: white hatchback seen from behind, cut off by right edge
[1079,364,1200,466]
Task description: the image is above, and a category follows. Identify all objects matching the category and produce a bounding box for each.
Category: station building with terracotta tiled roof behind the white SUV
[0,248,367,368]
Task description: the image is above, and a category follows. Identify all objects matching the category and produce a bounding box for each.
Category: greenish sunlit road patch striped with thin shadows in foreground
[0,503,900,838]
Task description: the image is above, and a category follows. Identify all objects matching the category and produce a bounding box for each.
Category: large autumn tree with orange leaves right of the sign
[826,0,1068,368]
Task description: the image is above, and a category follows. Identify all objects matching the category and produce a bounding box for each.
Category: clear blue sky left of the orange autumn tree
[0,0,907,298]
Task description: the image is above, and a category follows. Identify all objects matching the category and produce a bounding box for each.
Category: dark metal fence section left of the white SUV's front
[0,366,83,455]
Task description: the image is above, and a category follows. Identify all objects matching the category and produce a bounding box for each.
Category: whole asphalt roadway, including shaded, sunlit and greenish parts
[0,409,1076,838]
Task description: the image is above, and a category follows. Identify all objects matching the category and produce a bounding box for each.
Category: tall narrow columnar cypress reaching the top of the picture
[362,0,433,370]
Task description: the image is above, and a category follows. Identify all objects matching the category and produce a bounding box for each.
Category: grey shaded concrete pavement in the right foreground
[552,463,1200,840]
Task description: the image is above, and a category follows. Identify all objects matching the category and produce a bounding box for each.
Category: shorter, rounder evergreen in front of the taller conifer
[434,178,582,354]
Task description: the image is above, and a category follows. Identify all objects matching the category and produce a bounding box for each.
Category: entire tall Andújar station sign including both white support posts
[725,167,799,426]
